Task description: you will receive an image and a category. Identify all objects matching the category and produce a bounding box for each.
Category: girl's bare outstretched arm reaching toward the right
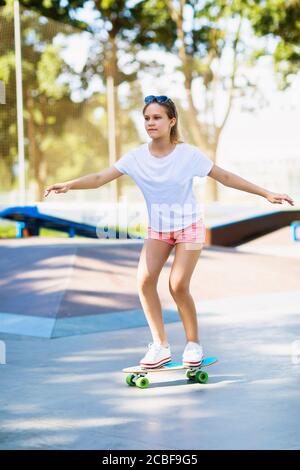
[208,165,294,206]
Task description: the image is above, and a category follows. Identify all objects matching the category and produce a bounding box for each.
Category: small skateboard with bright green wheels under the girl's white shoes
[122,357,218,388]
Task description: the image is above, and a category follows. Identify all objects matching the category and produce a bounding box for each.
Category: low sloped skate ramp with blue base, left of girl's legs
[0,237,164,338]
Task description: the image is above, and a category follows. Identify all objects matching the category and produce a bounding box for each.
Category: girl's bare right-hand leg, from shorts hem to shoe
[169,243,202,342]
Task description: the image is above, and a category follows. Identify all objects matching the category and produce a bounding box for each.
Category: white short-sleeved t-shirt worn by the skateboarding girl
[114,143,213,232]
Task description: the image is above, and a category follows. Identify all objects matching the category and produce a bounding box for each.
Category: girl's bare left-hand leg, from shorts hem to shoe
[137,239,173,345]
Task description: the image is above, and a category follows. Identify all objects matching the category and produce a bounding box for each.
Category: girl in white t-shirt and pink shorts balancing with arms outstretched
[45,95,294,368]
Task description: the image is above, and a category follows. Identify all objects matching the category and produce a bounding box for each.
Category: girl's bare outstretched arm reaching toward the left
[44,166,123,197]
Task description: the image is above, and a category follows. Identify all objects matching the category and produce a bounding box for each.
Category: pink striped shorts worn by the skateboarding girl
[145,219,205,246]
